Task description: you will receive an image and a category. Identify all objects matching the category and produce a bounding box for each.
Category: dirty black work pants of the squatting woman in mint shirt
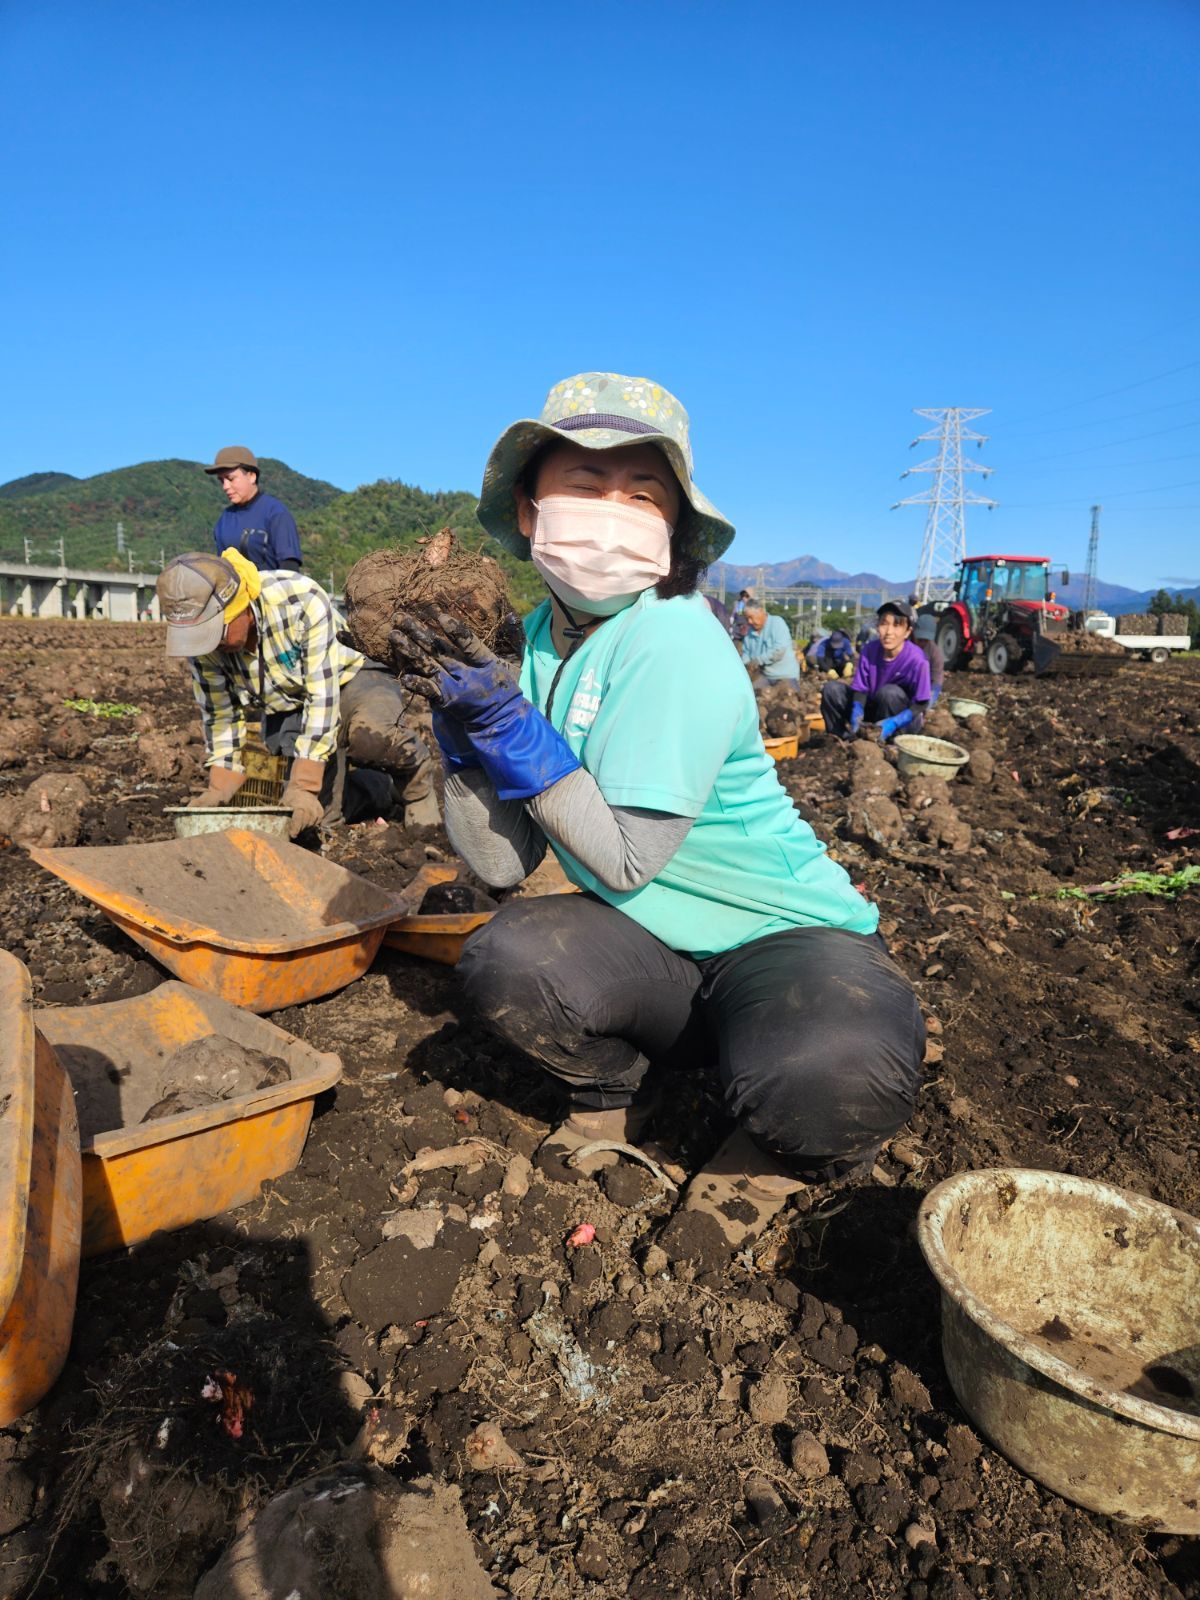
[458,894,925,1178]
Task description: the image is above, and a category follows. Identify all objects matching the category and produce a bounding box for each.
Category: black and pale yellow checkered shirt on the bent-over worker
[192,573,363,771]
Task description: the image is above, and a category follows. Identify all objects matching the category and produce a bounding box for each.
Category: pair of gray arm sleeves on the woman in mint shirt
[445,766,693,893]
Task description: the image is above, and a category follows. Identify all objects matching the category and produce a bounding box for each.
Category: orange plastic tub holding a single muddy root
[38,979,342,1256]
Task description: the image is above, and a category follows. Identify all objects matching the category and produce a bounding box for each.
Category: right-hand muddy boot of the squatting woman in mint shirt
[659,1128,808,1267]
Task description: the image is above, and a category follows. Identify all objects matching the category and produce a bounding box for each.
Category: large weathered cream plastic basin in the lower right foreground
[918,1168,1200,1534]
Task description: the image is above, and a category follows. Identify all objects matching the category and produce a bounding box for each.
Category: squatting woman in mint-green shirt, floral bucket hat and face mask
[392,373,925,1261]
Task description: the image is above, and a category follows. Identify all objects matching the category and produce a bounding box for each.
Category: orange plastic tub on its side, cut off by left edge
[0,950,82,1427]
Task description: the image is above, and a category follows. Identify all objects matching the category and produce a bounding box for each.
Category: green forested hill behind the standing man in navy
[0,458,546,610]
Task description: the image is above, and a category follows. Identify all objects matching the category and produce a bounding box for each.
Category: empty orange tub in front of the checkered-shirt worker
[29,829,406,1011]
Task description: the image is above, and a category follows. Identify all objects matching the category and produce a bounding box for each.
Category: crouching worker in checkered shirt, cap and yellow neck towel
[157,550,440,838]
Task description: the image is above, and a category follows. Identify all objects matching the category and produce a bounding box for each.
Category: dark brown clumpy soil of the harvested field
[0,619,1200,1600]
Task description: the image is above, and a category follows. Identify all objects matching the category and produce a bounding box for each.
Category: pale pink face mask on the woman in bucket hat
[530,494,672,616]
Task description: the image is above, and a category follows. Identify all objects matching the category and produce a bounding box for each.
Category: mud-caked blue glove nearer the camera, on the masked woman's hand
[389,613,581,800]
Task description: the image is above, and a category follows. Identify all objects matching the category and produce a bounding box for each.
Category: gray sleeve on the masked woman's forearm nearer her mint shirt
[525,766,694,891]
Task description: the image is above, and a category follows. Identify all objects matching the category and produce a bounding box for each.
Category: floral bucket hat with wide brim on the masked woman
[478,373,733,562]
